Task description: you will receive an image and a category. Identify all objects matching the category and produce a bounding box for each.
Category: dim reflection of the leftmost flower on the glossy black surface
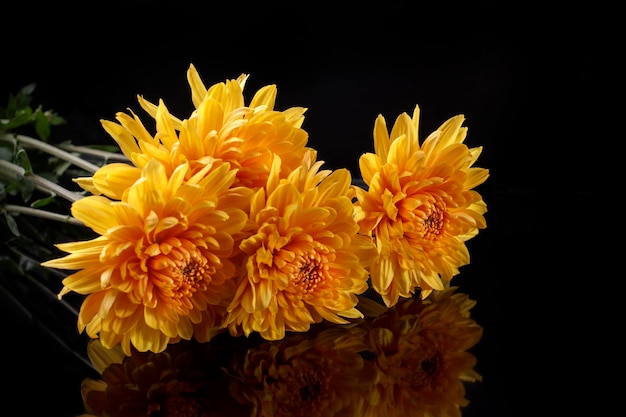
[82,340,251,417]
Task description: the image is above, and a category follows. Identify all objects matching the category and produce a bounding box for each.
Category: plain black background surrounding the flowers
[0,0,623,417]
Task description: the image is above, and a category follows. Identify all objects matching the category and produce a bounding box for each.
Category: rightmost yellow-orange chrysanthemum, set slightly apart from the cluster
[355,106,489,306]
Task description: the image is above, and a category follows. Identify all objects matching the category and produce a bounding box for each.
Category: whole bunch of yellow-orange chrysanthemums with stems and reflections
[0,65,489,417]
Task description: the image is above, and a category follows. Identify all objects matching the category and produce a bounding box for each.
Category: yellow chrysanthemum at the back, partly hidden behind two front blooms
[76,65,310,199]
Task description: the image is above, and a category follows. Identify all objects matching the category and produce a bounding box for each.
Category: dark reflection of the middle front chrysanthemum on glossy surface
[231,325,376,417]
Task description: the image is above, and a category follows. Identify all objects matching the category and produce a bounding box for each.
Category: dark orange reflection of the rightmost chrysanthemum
[363,287,482,417]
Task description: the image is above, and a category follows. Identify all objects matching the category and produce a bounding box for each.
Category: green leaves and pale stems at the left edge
[0,84,94,244]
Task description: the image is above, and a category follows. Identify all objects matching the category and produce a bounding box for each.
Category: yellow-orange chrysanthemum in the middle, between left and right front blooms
[225,153,375,340]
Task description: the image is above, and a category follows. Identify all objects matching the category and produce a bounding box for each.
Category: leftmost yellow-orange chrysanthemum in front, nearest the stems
[43,160,250,354]
